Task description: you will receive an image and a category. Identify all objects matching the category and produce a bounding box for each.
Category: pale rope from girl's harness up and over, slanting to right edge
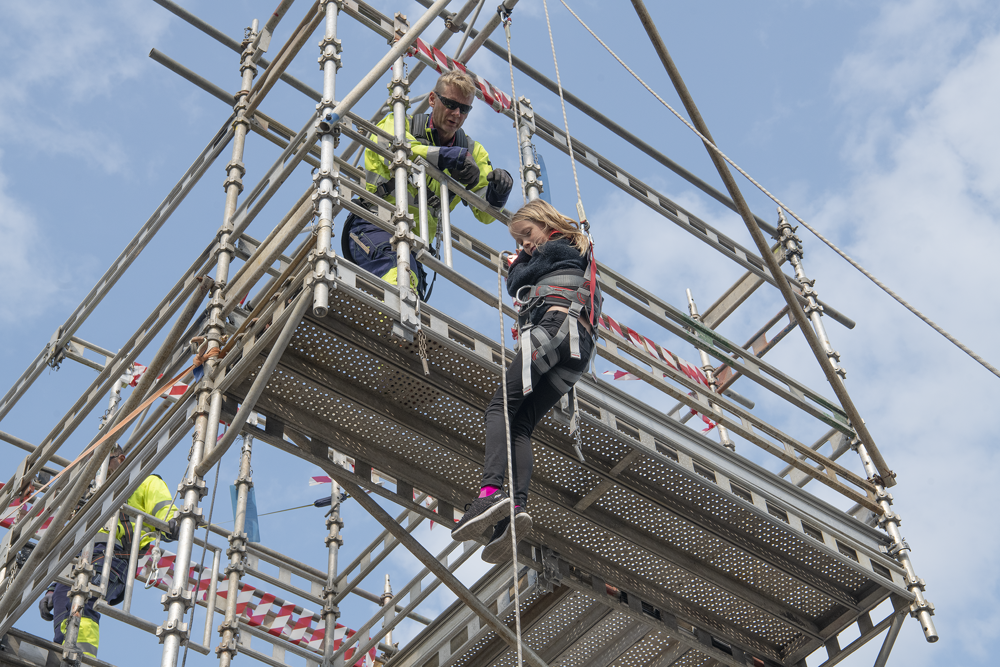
[556,0,1000,377]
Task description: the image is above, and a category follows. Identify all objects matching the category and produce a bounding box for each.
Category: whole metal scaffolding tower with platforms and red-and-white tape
[0,0,937,667]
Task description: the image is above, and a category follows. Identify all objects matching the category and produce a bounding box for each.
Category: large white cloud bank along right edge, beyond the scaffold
[809,2,1000,665]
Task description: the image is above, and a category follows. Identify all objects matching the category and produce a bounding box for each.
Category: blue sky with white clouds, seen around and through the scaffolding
[0,0,1000,667]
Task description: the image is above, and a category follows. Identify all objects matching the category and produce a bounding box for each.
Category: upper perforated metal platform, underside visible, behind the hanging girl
[225,266,911,667]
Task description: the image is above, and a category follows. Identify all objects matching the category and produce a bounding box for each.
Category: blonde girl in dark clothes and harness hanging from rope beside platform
[451,199,601,563]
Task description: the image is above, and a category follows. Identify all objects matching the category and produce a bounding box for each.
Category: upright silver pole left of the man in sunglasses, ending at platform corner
[312,0,343,317]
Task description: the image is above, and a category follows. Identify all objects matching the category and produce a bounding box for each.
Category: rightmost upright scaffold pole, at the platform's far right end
[778,213,938,643]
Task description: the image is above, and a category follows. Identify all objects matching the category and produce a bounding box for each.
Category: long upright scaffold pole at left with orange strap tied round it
[156,19,258,667]
